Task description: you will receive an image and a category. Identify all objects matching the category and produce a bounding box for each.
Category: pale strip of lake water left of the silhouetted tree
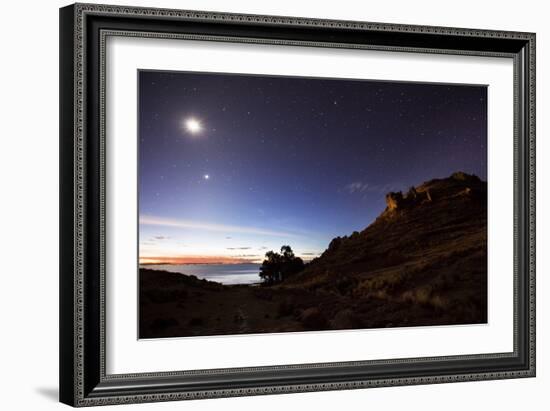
[140,263,261,284]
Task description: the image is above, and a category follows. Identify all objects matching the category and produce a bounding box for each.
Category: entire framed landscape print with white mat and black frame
[60,4,535,406]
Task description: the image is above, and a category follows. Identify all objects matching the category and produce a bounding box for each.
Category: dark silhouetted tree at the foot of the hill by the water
[260,245,304,285]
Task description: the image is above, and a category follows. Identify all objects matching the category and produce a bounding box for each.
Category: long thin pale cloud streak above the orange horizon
[139,215,297,237]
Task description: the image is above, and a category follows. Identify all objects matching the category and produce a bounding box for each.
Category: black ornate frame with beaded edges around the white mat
[60,4,535,406]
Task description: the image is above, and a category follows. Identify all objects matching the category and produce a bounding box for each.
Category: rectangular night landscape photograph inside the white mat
[140,70,488,339]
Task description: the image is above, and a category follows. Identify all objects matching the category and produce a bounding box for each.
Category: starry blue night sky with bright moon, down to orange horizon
[138,71,487,263]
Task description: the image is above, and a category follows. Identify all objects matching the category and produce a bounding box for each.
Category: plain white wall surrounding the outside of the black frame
[0,0,550,411]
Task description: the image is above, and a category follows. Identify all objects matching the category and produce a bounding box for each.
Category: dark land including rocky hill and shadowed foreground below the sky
[140,172,487,337]
